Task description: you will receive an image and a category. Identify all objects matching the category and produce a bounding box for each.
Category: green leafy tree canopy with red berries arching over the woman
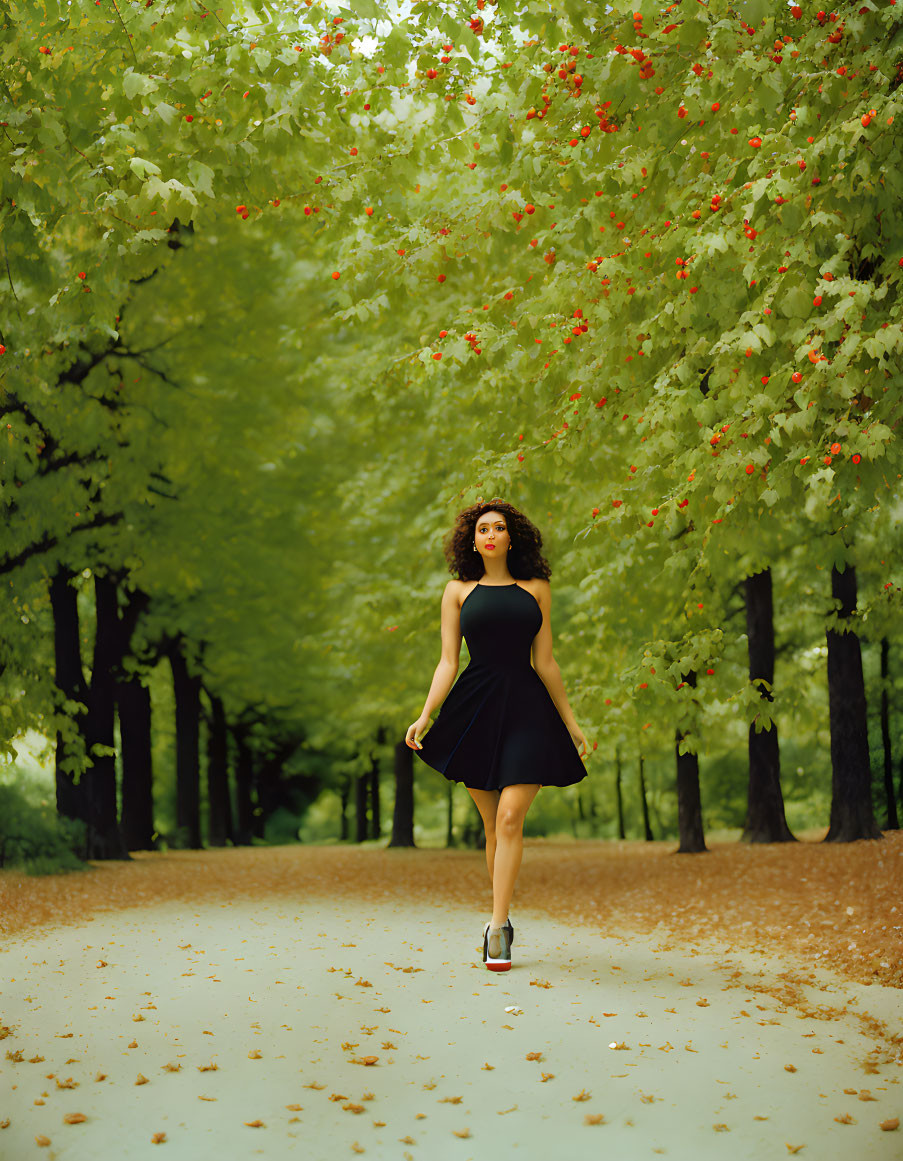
[0,0,903,840]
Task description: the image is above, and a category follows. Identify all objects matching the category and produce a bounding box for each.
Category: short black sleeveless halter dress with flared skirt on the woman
[414,581,586,791]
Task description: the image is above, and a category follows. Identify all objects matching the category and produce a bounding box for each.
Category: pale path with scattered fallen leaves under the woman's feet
[0,848,903,1161]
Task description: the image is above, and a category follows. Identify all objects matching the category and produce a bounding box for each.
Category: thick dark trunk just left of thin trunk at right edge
[824,564,882,843]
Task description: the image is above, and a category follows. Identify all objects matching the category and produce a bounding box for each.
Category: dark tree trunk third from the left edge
[116,677,157,851]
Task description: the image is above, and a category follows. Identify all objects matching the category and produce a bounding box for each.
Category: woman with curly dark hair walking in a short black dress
[405,499,587,972]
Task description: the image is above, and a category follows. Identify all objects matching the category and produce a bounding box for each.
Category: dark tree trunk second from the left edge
[82,572,129,859]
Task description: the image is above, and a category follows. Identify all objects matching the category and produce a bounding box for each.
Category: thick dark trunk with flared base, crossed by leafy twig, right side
[741,569,796,843]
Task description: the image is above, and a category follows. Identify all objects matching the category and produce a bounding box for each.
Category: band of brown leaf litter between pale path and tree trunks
[0,830,903,988]
